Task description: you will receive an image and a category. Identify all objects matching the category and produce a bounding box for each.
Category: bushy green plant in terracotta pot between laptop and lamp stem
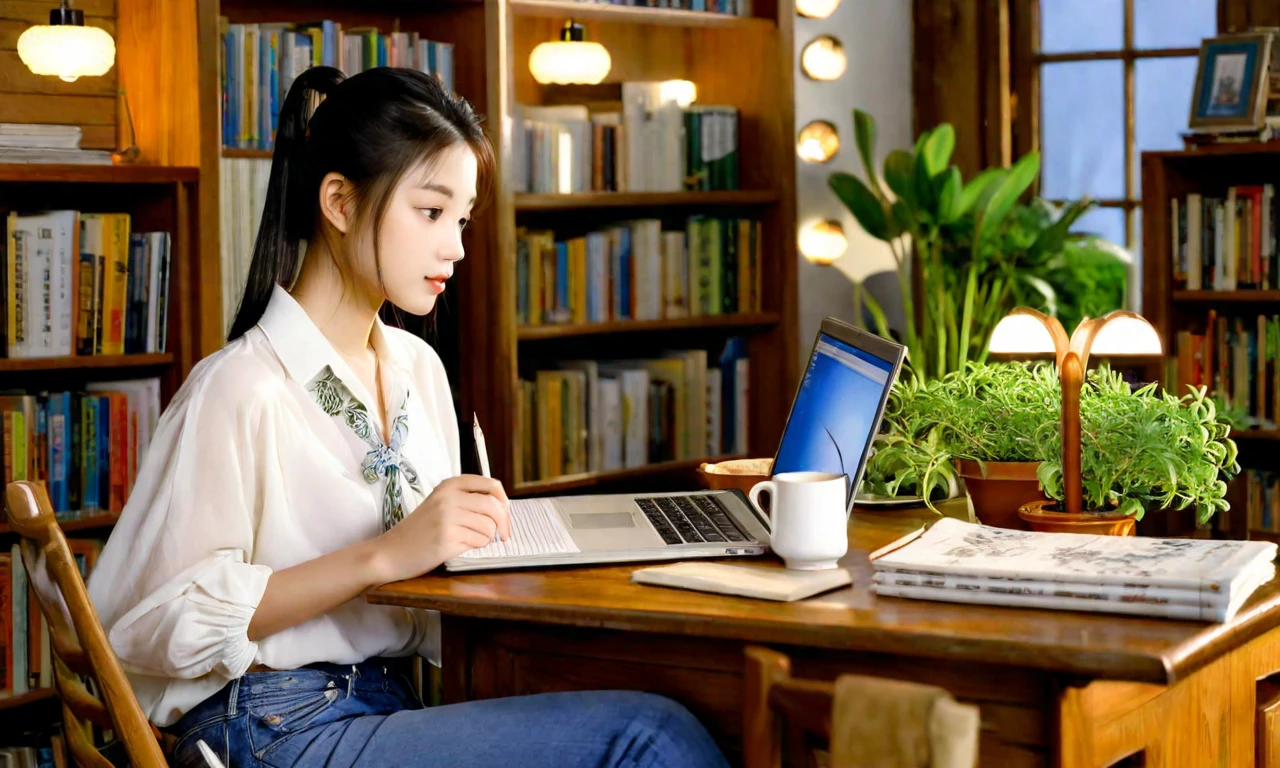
[867,362,1060,529]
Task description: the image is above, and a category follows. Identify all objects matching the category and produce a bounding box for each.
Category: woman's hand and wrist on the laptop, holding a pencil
[379,475,511,581]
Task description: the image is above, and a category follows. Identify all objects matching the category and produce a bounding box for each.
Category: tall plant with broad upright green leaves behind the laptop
[829,110,1039,376]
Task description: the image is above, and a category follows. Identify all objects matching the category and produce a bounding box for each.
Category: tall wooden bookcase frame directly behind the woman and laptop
[201,0,797,495]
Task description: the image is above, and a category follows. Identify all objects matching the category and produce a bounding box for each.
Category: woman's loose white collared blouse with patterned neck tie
[88,287,461,726]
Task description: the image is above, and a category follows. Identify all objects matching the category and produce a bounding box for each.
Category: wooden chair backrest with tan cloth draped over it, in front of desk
[742,646,979,768]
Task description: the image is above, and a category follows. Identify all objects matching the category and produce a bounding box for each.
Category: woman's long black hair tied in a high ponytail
[227,67,493,340]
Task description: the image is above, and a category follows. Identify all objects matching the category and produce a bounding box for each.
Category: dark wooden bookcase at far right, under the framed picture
[1142,142,1280,540]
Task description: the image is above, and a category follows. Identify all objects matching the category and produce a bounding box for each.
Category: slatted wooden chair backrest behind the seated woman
[5,480,168,768]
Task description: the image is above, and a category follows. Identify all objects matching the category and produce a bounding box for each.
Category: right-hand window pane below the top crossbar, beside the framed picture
[1133,56,1197,185]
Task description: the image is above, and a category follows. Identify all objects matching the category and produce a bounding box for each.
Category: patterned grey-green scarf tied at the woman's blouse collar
[307,366,422,531]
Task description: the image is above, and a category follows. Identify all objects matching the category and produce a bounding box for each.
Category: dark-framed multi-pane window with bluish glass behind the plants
[1015,0,1217,305]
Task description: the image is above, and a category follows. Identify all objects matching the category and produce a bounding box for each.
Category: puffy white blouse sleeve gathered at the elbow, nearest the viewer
[90,353,282,680]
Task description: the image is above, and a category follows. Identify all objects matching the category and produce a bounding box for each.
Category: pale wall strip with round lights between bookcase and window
[795,0,915,370]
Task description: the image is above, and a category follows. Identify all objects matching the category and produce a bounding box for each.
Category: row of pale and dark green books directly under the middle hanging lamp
[512,90,740,195]
